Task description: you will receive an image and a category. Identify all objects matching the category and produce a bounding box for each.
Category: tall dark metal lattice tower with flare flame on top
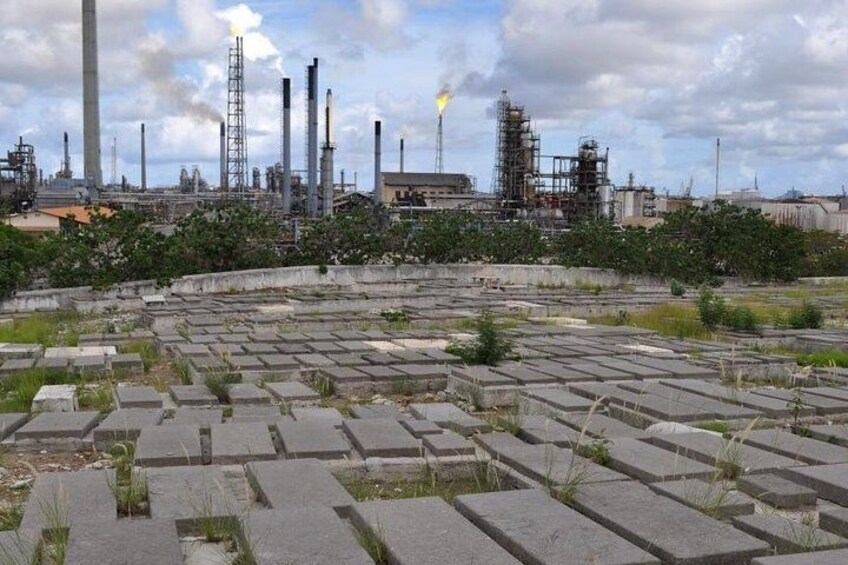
[227,37,247,193]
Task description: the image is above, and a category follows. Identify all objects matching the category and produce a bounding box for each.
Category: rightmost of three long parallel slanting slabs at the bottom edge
[574,481,770,565]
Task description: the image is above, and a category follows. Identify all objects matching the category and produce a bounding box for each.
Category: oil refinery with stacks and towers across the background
[0,0,848,234]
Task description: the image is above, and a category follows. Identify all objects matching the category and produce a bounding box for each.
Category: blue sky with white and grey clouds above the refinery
[0,0,848,195]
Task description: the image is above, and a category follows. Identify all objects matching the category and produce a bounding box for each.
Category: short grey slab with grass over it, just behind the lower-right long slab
[650,479,756,520]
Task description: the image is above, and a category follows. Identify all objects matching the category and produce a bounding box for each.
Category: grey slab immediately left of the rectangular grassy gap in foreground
[246,459,354,516]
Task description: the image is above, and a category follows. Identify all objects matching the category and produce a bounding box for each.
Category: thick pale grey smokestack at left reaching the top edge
[82,0,103,187]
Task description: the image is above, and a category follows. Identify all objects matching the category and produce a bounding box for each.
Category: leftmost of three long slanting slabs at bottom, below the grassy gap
[351,497,520,565]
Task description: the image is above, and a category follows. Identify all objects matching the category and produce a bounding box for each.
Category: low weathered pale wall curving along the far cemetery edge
[0,265,665,314]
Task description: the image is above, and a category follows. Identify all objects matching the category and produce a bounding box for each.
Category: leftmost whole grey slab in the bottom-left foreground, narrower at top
[20,471,118,531]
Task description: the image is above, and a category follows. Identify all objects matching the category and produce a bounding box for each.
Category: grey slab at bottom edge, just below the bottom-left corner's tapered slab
[65,519,183,565]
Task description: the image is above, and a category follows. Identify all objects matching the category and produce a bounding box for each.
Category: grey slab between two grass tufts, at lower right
[608,438,716,483]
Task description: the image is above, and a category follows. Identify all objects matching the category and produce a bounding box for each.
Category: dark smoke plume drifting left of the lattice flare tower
[138,43,224,123]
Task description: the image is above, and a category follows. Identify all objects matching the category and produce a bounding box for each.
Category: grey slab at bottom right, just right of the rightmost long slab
[733,514,848,553]
